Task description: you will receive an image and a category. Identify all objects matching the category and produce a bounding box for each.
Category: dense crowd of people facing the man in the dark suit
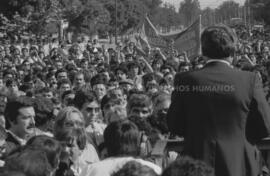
[0,23,270,176]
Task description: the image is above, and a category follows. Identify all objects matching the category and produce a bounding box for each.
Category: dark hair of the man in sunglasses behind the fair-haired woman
[73,90,98,109]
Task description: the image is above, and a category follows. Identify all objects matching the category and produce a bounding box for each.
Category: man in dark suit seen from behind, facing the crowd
[168,26,270,176]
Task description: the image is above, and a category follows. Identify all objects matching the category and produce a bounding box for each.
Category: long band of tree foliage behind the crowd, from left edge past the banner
[0,0,184,35]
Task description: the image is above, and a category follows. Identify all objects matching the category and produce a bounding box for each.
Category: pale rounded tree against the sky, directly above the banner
[179,0,201,26]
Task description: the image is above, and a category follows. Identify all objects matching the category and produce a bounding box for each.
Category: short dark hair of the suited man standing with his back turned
[201,25,237,59]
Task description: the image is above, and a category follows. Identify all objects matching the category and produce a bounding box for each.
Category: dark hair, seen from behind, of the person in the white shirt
[104,119,140,156]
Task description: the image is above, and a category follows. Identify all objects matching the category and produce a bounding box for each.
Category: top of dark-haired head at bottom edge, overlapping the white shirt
[112,161,157,176]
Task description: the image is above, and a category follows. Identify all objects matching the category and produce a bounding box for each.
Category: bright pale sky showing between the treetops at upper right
[163,0,245,9]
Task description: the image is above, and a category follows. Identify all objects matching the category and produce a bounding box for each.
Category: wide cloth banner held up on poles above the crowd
[137,17,201,58]
